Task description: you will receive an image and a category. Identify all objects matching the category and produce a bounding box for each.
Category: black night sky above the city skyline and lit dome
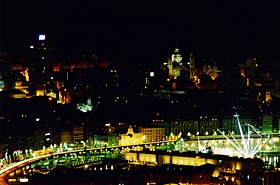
[2,0,280,62]
